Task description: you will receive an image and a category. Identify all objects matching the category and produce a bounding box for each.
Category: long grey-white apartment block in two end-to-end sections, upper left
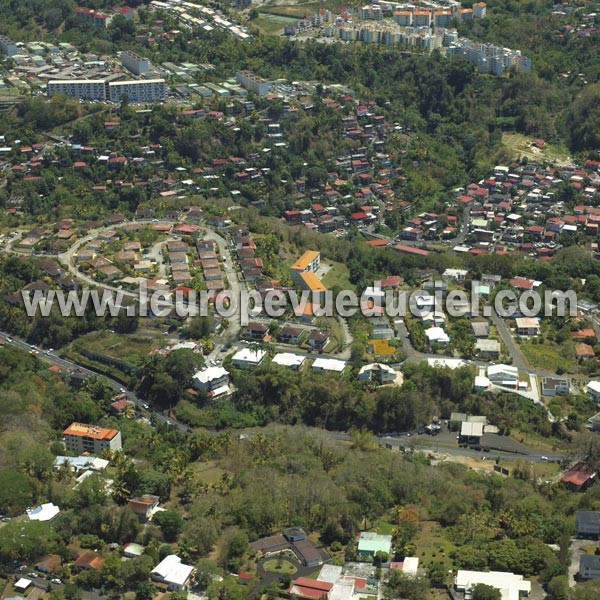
[46,79,167,102]
